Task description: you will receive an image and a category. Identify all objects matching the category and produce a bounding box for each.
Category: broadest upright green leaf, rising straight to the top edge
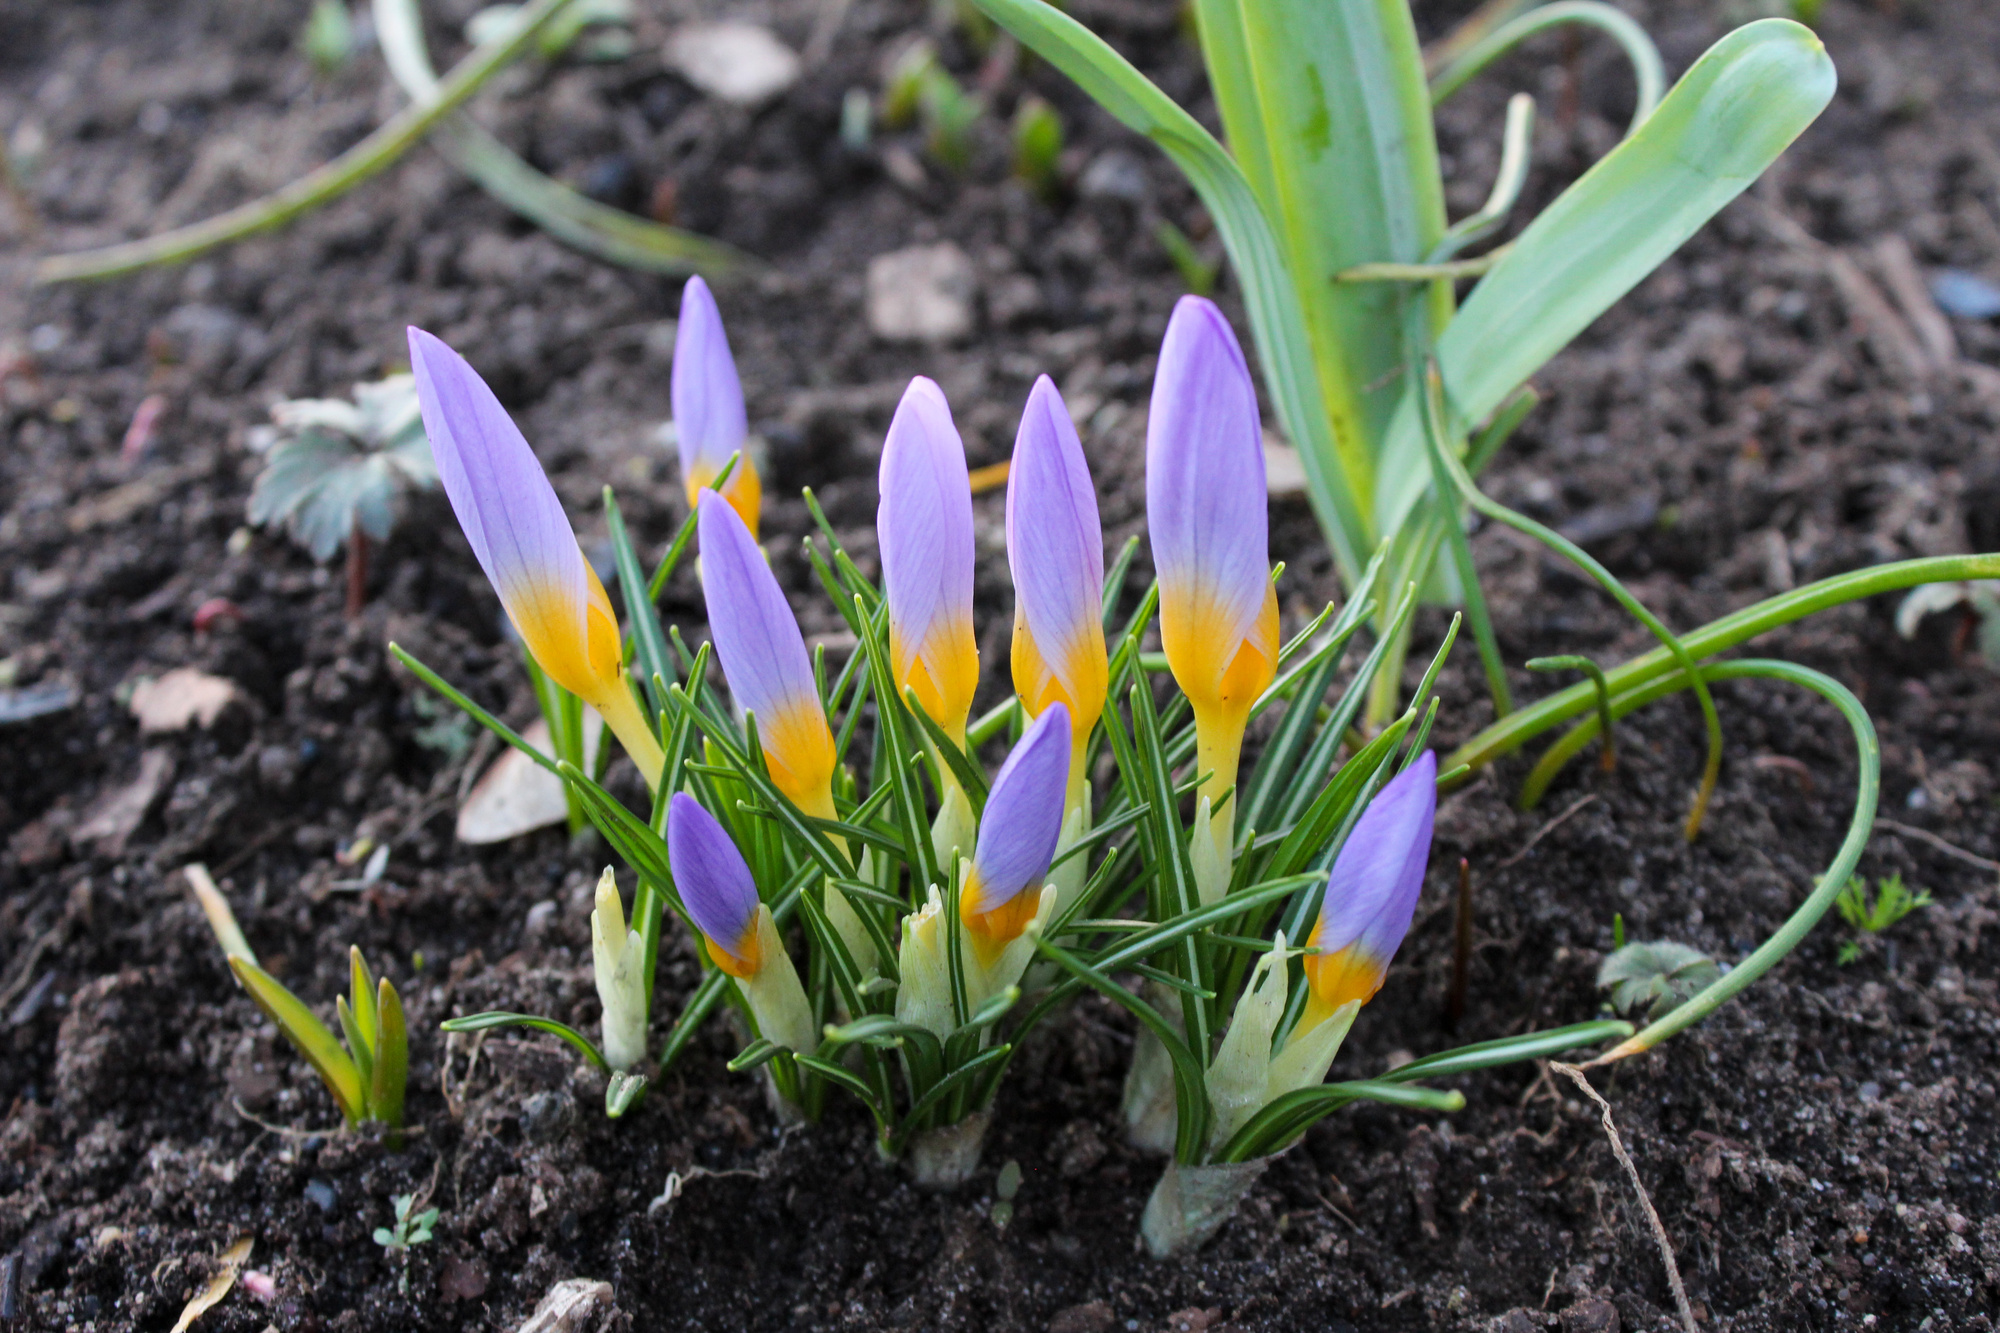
[1194,0,1450,512]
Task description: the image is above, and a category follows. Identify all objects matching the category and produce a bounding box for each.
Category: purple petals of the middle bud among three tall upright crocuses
[1006,374,1104,697]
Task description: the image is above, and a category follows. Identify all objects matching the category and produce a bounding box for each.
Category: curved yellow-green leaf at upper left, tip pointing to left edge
[34,0,570,286]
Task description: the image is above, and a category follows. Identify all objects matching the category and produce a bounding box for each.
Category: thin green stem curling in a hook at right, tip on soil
[1578,658,1882,1065]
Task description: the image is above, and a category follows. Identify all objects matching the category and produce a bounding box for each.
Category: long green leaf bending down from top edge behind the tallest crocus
[974,0,1376,580]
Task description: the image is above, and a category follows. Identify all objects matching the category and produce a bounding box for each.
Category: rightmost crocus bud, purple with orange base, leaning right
[1294,751,1438,1020]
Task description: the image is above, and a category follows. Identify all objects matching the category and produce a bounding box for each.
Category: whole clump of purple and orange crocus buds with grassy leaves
[406,280,1608,1253]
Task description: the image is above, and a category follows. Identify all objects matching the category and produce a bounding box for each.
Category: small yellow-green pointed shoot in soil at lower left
[230,947,410,1147]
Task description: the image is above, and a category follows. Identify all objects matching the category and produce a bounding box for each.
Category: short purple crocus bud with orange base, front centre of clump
[958,703,1070,965]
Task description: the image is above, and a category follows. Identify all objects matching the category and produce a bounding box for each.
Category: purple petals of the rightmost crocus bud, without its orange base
[1312,751,1438,963]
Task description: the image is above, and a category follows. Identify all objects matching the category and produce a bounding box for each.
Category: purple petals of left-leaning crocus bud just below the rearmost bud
[696,490,818,725]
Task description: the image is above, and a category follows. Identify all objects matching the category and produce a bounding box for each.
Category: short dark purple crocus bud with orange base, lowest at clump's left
[666,793,818,1051]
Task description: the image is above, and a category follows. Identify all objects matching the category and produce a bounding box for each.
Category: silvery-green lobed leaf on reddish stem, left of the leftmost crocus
[250,374,438,620]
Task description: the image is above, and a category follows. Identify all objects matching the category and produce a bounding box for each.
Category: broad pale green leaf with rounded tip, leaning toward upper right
[1376,18,1834,530]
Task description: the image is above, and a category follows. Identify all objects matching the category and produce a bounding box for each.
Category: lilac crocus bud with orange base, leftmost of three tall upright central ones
[876,376,980,740]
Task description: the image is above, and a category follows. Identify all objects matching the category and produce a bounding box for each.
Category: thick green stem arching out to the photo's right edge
[1438,552,2000,773]
